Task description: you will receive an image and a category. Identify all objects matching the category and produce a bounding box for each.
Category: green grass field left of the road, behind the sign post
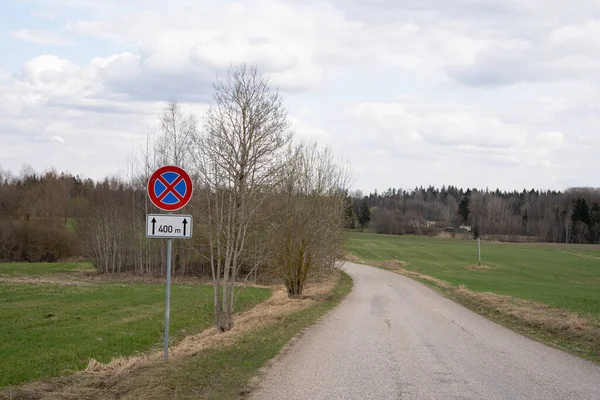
[0,263,271,387]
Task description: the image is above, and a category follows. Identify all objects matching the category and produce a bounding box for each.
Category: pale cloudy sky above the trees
[0,0,600,193]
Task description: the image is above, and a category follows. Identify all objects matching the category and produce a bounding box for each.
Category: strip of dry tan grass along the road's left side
[0,273,340,400]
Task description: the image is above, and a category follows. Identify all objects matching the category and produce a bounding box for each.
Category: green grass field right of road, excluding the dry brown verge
[347,233,600,314]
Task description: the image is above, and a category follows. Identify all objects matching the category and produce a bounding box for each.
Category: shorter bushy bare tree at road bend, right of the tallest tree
[268,144,350,297]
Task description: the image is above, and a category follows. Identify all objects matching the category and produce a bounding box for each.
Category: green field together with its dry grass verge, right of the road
[347,233,600,362]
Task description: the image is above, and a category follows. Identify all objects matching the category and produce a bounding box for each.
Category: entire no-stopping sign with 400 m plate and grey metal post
[146,165,193,361]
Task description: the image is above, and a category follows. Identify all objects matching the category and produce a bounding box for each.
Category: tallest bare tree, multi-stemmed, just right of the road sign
[196,64,291,331]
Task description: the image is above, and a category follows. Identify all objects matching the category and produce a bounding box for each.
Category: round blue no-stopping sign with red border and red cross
[148,165,192,211]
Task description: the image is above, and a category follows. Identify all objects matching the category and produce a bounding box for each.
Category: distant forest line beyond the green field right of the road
[346,186,600,243]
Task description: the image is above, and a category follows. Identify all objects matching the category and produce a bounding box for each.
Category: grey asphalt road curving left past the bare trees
[251,263,600,400]
